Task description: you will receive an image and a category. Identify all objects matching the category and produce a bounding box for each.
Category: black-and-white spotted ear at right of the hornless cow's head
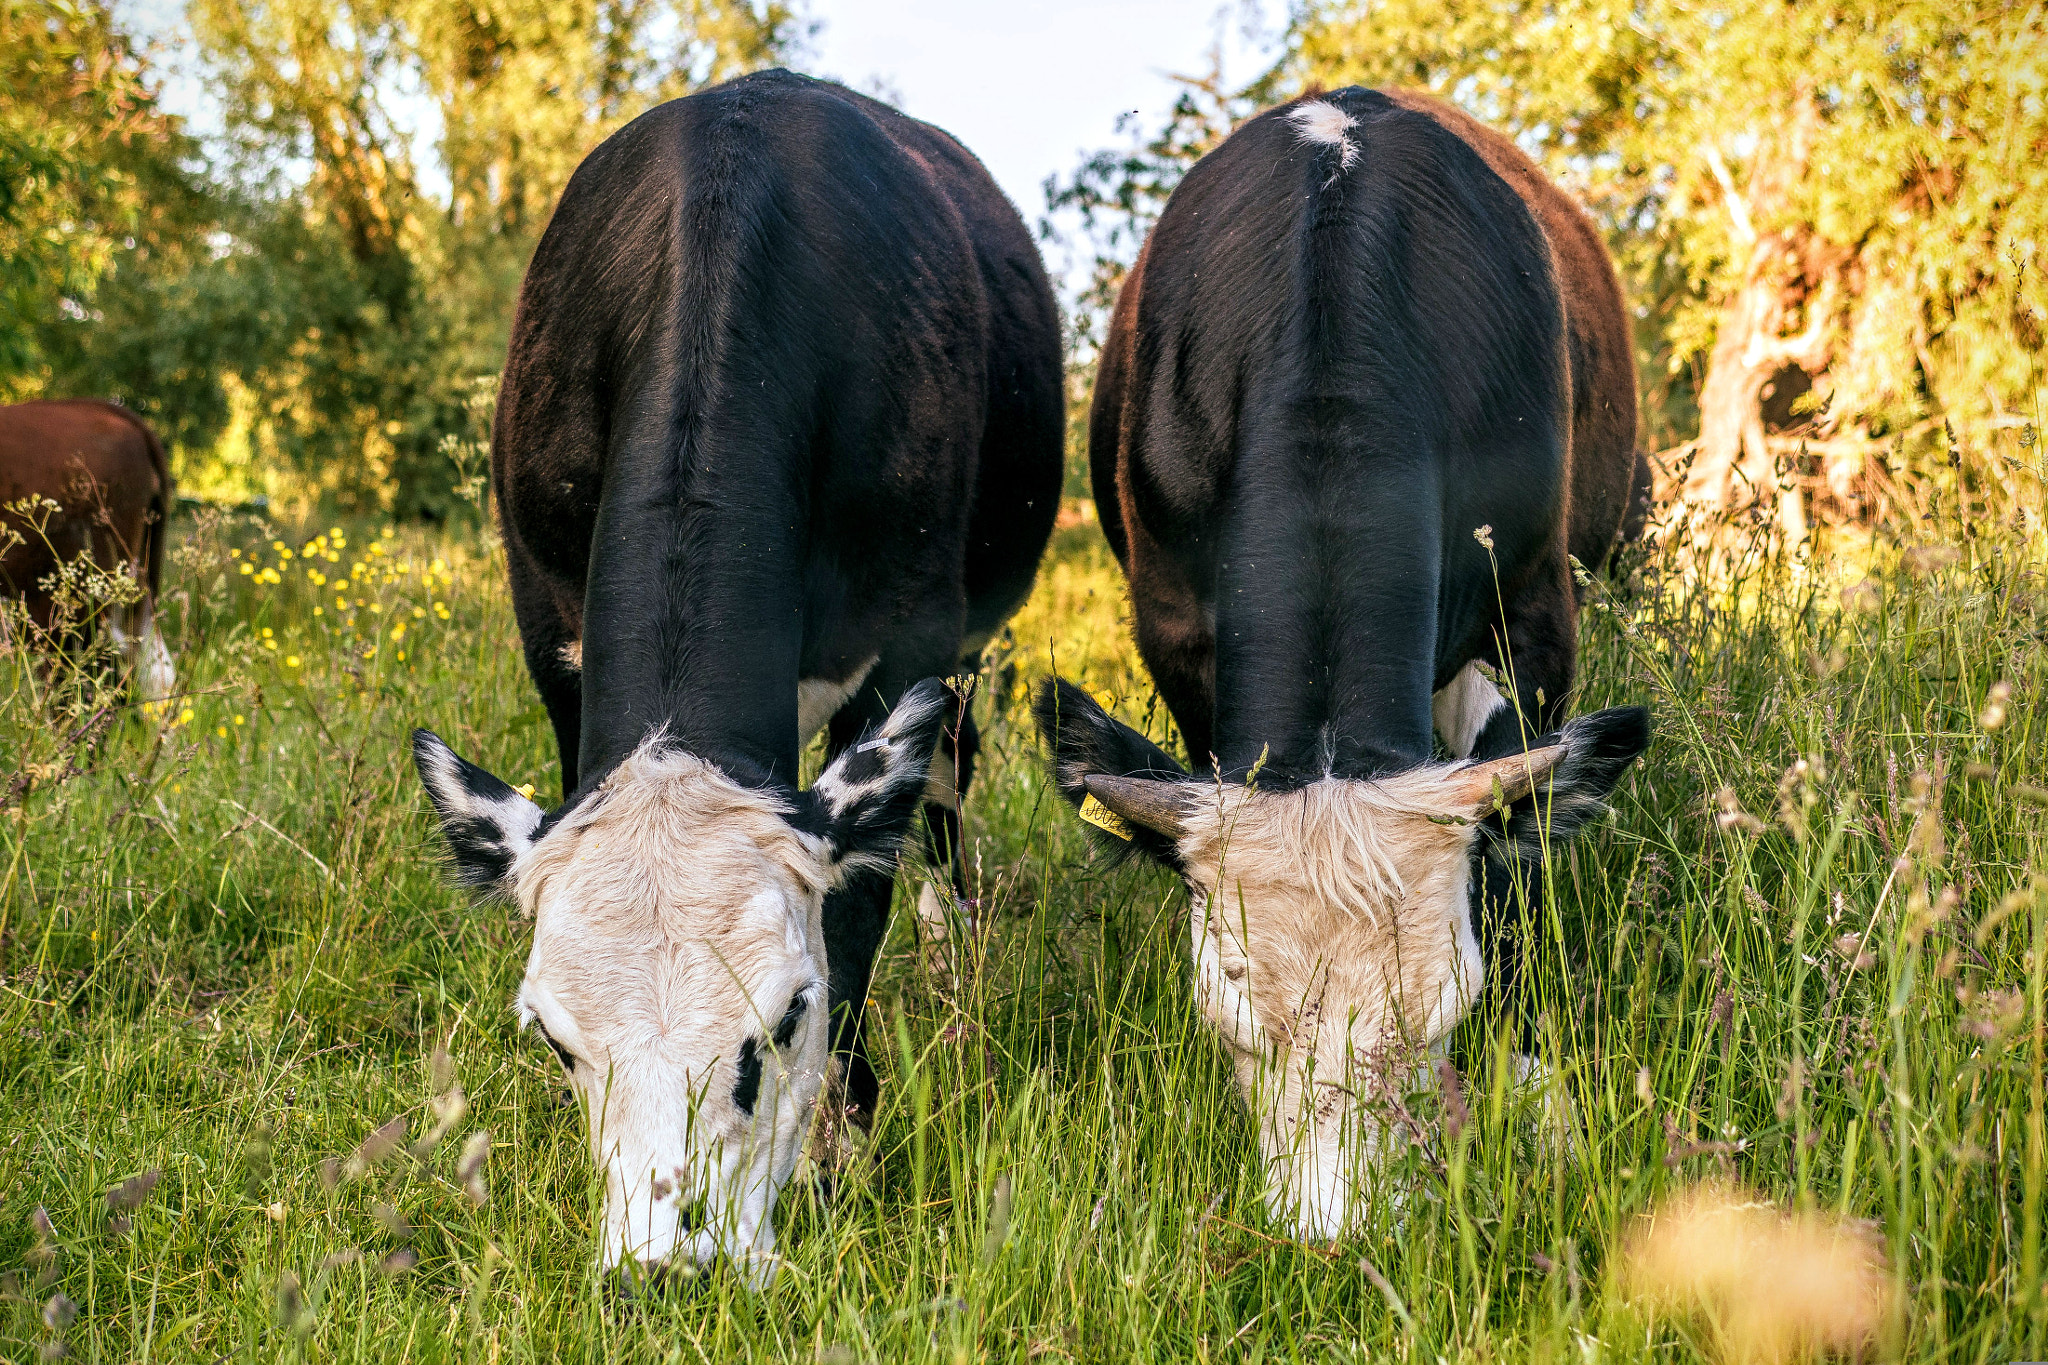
[811,677,956,880]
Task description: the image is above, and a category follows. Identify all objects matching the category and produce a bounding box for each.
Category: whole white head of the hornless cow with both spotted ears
[414,684,944,1285]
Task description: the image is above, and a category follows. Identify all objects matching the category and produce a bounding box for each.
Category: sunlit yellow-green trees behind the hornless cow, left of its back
[6,0,807,514]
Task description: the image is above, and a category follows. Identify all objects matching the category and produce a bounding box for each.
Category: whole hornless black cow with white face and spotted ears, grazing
[416,72,1063,1283]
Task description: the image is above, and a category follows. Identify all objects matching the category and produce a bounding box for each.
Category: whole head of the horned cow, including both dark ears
[1038,684,1649,1236]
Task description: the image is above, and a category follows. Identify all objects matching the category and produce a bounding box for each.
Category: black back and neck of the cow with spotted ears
[494,72,1059,789]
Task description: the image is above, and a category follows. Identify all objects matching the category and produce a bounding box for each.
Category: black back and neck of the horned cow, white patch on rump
[1092,90,1569,774]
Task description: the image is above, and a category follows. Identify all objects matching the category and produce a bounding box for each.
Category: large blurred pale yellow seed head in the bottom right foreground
[1618,1183,1886,1365]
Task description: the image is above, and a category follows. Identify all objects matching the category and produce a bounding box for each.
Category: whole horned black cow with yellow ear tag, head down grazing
[1038,88,1649,1236]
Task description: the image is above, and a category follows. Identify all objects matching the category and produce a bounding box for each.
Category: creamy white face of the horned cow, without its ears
[1180,769,1561,1238]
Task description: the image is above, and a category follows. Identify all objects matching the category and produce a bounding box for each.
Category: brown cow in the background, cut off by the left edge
[0,399,176,700]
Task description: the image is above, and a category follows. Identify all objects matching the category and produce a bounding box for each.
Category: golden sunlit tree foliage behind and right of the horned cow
[1061,0,2048,517]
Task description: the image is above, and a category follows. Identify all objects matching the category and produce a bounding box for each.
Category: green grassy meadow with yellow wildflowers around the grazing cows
[0,462,2048,1365]
